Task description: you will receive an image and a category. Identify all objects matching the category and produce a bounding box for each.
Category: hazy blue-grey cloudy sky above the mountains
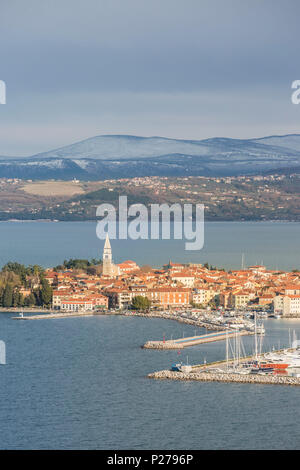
[0,0,300,156]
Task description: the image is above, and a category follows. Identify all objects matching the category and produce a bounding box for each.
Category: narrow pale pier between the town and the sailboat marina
[143,330,253,349]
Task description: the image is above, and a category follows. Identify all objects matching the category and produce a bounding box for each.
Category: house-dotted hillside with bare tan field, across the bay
[0,173,300,221]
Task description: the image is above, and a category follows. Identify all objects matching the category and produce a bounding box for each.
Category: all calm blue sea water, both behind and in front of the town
[0,222,300,449]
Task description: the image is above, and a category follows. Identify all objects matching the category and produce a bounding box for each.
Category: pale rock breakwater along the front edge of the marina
[148,370,300,386]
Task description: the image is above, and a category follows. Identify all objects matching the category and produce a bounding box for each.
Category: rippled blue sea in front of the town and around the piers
[0,314,300,449]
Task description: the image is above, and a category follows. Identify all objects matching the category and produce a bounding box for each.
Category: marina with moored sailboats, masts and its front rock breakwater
[148,317,300,385]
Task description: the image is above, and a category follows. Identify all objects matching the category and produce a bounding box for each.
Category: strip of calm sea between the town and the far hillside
[0,222,300,269]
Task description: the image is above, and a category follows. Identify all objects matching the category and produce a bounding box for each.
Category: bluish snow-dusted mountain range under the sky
[0,135,300,180]
